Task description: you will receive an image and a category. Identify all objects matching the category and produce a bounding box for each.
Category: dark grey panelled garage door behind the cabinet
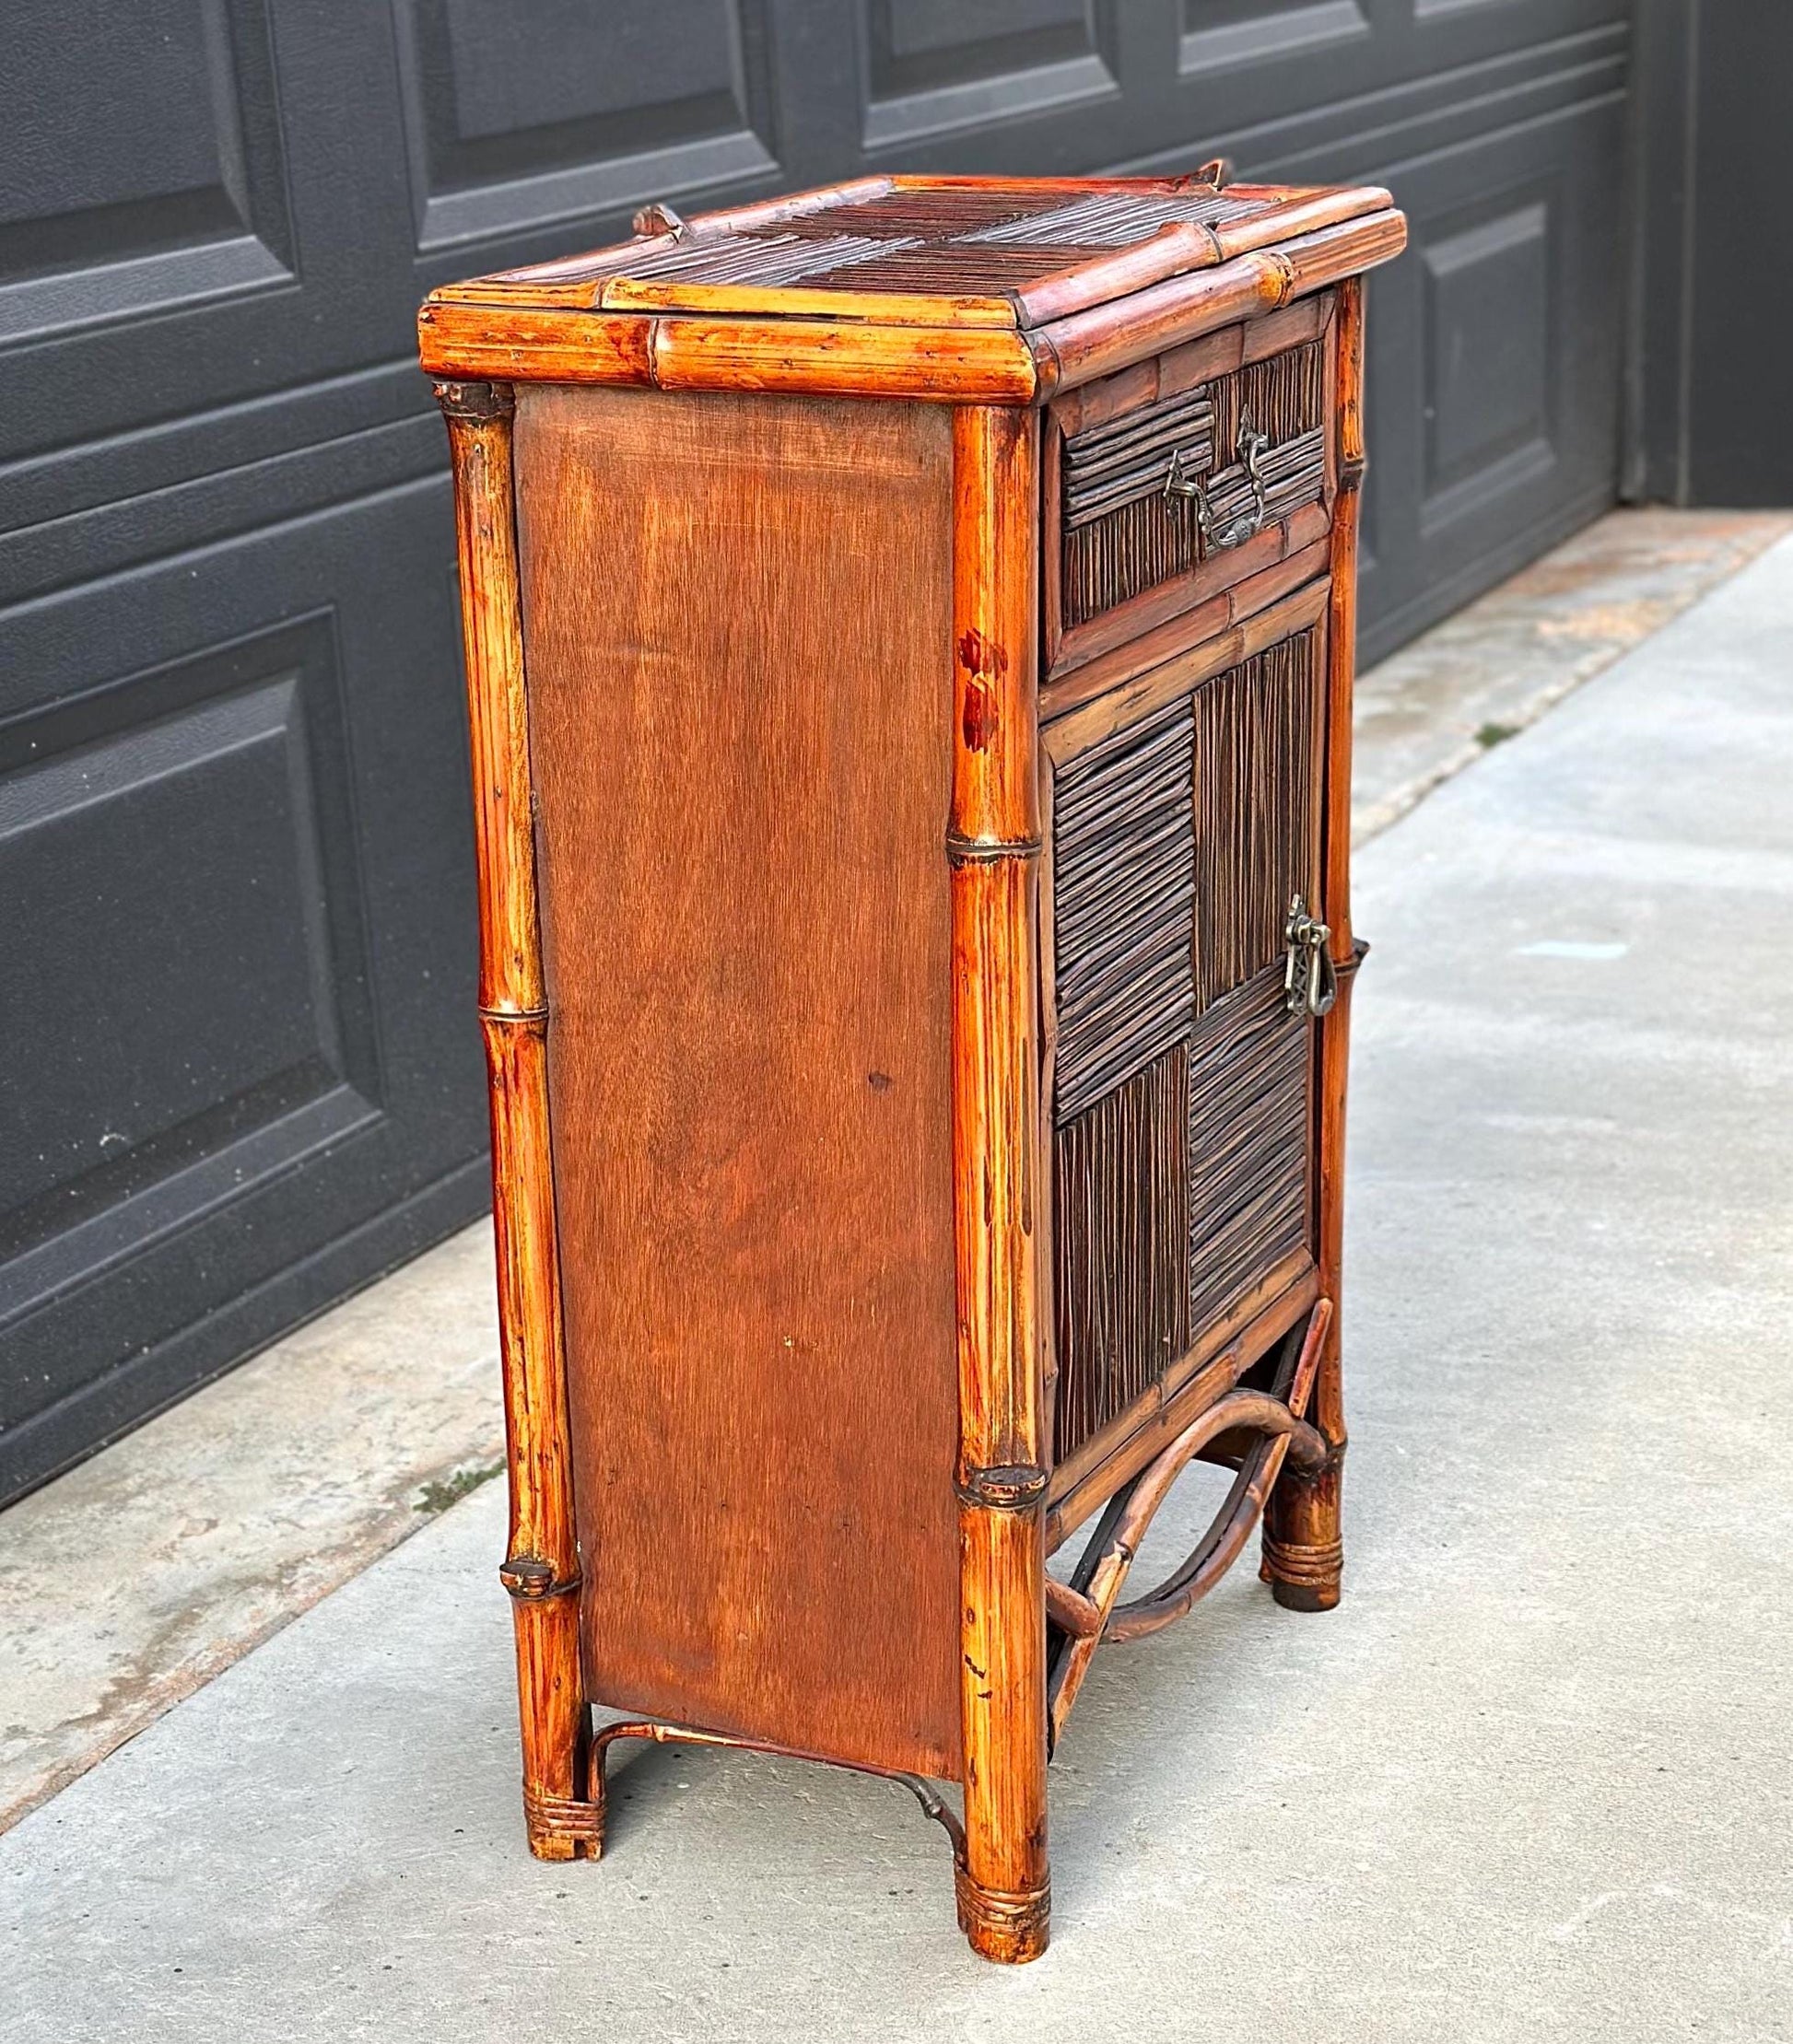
[0,0,1627,1494]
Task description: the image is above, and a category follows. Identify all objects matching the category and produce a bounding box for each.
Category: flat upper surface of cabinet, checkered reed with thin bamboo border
[427,178,1390,327]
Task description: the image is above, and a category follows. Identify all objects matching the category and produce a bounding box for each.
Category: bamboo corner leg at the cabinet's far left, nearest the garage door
[436,382,601,1860]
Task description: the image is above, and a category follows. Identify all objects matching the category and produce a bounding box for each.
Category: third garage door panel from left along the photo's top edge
[865,0,1120,149]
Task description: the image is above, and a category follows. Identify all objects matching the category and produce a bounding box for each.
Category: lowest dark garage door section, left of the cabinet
[0,478,483,1496]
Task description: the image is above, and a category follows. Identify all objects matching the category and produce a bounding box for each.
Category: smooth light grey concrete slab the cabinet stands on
[0,542,1793,2044]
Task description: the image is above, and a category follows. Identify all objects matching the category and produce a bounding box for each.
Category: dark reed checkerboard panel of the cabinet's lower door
[1051,624,1325,1459]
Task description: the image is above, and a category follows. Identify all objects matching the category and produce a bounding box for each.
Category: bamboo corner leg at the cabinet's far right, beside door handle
[1263,278,1364,1611]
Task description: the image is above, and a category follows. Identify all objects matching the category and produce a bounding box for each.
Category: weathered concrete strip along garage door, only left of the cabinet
[0,1222,505,1831]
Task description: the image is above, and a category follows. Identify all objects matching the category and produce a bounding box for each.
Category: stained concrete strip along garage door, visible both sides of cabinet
[0,509,1793,1831]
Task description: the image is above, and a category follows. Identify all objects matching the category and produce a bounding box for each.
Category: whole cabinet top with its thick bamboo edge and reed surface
[417,166,1407,407]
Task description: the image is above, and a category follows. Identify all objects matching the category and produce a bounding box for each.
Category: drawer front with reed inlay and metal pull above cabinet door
[1045,295,1333,679]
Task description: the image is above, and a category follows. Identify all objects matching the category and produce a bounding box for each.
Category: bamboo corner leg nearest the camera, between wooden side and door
[949,407,1051,1962]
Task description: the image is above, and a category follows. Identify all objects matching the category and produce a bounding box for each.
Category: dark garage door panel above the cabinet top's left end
[394,0,777,253]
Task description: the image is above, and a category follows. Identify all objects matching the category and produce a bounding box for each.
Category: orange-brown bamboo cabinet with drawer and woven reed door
[419,166,1404,1960]
